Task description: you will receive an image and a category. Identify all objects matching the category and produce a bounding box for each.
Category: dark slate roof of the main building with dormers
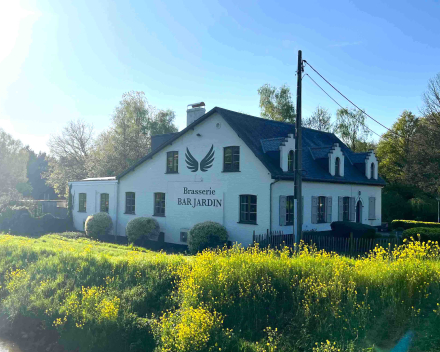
[118,107,385,185]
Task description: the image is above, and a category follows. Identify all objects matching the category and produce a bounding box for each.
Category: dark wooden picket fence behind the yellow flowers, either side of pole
[253,231,401,255]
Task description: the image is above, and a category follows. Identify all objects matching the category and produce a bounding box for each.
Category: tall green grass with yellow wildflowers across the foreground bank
[0,235,440,352]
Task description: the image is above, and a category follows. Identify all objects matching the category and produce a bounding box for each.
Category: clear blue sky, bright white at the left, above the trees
[0,0,440,151]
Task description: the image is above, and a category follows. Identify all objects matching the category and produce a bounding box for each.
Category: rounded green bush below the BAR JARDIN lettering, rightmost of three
[188,221,228,253]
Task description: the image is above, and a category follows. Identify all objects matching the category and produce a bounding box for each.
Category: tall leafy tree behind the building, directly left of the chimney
[88,91,177,176]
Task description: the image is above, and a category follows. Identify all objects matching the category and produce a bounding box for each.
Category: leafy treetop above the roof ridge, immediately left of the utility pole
[258,84,296,124]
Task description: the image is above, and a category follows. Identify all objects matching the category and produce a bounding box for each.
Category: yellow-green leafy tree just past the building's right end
[376,110,419,184]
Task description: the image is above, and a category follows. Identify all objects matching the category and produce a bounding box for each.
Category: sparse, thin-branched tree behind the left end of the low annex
[44,120,93,197]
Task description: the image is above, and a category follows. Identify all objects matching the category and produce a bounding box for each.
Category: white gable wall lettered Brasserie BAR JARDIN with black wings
[118,114,272,245]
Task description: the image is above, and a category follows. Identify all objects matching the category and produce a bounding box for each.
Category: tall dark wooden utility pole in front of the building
[293,50,303,243]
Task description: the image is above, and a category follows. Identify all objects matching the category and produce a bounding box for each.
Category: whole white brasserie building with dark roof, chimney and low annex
[71,104,385,245]
